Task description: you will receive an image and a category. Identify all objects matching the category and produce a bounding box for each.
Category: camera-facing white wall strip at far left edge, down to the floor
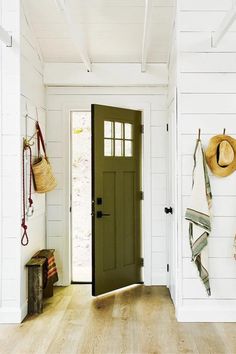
[0,0,21,323]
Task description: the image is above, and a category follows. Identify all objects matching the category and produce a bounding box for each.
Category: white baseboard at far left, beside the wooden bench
[0,301,28,324]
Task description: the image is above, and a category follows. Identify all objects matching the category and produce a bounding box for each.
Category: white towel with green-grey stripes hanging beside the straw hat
[185,140,212,296]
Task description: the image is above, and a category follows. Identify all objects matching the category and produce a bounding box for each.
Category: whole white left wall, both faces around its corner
[0,0,45,323]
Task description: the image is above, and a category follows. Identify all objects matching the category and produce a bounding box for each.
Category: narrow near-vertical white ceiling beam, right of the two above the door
[141,0,152,72]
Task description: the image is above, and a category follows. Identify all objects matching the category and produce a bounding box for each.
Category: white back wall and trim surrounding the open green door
[47,87,167,284]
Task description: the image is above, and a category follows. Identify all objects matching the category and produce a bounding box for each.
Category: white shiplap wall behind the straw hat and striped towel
[178,0,236,321]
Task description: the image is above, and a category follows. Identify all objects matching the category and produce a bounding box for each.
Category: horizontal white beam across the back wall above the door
[44,63,168,89]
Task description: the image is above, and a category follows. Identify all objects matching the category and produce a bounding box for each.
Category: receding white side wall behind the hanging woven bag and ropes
[21,1,46,304]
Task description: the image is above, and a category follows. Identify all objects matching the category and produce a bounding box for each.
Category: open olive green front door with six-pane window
[92,105,141,295]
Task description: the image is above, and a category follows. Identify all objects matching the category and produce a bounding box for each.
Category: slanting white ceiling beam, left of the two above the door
[55,0,92,71]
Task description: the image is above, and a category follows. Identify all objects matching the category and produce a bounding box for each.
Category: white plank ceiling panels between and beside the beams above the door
[27,0,174,63]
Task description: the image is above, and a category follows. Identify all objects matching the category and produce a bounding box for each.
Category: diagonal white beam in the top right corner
[212,0,236,47]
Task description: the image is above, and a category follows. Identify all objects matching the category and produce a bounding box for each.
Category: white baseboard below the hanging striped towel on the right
[176,307,236,322]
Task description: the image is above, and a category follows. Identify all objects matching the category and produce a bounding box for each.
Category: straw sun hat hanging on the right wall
[205,134,236,177]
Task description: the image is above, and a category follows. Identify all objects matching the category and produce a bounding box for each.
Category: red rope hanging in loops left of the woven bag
[21,141,33,246]
